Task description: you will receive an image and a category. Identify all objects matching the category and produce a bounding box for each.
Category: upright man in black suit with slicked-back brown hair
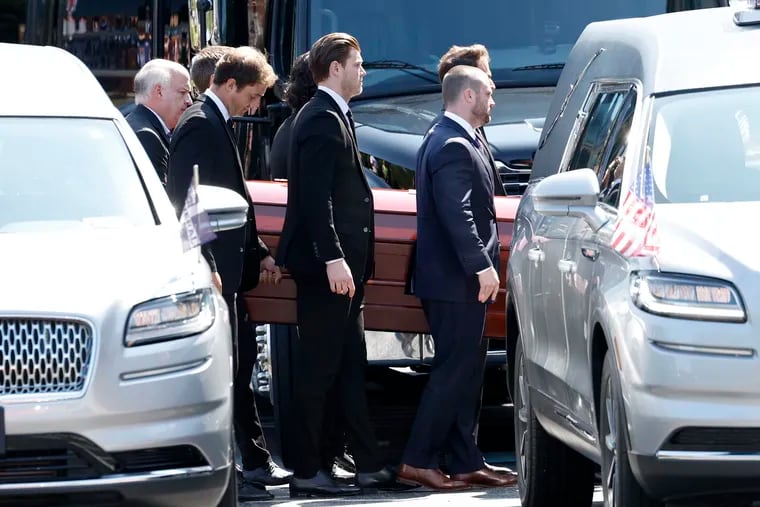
[277,33,410,496]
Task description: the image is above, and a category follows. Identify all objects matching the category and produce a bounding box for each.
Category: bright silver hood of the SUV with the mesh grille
[0,225,208,316]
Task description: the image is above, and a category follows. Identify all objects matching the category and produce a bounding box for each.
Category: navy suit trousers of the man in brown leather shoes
[402,299,487,474]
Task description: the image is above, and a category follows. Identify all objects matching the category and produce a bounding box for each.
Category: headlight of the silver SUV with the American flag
[630,271,747,322]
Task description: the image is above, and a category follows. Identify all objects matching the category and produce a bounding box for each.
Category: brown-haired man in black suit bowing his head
[166,47,290,501]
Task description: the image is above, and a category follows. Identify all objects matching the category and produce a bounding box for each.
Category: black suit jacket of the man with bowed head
[166,95,269,294]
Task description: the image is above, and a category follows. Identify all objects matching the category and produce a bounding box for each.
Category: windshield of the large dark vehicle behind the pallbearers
[309,0,676,96]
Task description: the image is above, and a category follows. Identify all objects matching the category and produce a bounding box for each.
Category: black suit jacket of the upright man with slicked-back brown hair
[277,90,375,283]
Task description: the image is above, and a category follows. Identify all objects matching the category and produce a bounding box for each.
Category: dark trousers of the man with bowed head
[224,293,272,470]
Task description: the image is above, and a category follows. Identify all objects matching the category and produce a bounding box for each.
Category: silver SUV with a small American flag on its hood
[507,6,760,507]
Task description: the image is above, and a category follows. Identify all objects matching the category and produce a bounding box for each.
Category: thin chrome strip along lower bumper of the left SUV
[0,465,214,492]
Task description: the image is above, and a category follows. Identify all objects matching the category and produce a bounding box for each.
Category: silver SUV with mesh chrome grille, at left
[0,44,247,507]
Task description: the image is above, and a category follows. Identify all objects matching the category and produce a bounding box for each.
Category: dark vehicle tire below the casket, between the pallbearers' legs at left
[269,324,298,469]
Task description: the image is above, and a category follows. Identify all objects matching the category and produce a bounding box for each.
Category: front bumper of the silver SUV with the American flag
[615,311,760,498]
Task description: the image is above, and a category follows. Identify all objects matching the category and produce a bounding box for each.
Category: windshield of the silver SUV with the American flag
[649,87,760,203]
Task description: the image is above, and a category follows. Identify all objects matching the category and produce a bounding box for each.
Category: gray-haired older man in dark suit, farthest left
[127,59,192,186]
